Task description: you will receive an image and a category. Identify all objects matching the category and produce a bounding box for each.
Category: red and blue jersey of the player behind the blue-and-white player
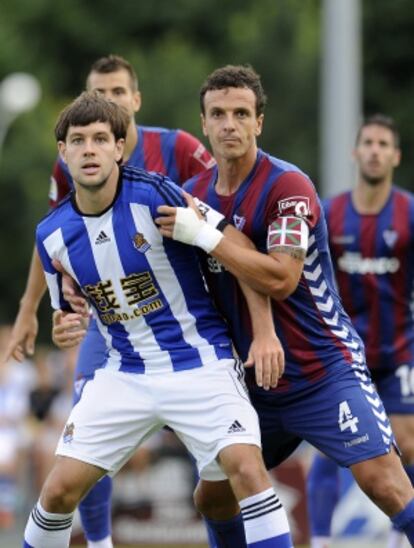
[49,126,214,208]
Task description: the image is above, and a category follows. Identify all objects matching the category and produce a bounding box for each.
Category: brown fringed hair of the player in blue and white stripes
[55,91,130,141]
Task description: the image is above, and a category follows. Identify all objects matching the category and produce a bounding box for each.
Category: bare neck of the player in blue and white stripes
[74,164,119,215]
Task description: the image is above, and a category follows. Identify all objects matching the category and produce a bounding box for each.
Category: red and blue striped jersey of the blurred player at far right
[324,187,414,370]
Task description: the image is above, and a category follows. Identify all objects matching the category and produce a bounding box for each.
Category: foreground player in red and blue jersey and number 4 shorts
[157,66,414,545]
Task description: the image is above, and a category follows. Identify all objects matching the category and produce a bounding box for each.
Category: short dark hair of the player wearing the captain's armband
[200,65,267,116]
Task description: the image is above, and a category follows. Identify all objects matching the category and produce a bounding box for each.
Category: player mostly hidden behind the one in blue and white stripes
[6,55,214,548]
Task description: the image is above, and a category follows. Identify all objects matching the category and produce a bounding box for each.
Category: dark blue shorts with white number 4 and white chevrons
[251,365,395,468]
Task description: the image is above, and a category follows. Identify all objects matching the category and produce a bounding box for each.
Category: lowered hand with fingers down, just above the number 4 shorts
[244,333,285,390]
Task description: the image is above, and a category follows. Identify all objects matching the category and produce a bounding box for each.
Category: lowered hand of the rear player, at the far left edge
[0,305,39,363]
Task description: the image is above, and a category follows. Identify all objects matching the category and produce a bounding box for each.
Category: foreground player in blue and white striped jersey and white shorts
[24,92,292,548]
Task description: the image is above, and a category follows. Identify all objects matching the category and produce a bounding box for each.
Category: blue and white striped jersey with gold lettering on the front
[36,167,233,373]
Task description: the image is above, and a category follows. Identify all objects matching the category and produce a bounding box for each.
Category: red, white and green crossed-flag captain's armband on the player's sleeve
[267,216,309,253]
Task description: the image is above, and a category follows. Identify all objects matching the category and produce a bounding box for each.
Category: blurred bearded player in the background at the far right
[308,114,414,548]
